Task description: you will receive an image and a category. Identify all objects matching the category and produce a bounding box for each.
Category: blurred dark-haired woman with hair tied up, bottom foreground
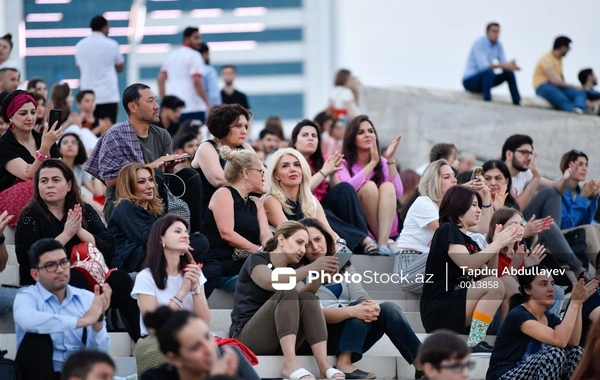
[141,306,241,380]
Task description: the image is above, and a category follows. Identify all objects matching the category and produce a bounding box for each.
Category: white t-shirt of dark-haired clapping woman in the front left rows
[131,268,206,335]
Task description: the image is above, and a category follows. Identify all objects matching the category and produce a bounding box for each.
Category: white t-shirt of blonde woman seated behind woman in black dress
[396,196,440,252]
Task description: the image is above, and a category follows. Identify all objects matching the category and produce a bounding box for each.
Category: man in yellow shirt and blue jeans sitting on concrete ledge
[533,36,586,113]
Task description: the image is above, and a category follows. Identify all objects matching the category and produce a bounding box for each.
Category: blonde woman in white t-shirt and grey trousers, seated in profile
[394,160,493,294]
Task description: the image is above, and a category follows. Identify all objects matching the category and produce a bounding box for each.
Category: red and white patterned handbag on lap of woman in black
[71,243,117,292]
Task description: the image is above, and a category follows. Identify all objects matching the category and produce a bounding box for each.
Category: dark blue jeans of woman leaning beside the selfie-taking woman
[327,300,421,364]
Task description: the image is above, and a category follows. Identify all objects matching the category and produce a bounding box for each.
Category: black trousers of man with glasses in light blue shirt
[15,333,60,380]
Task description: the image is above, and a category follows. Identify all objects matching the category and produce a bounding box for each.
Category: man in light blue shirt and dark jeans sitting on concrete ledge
[463,22,521,105]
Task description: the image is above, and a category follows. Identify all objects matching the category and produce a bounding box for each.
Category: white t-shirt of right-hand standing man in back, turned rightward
[160,46,207,113]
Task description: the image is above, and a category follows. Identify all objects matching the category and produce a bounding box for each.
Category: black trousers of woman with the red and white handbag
[69,270,140,342]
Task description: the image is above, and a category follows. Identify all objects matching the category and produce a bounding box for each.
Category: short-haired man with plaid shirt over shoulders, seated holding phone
[85,83,202,227]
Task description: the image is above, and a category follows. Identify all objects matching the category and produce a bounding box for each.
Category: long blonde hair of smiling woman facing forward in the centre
[263,148,317,218]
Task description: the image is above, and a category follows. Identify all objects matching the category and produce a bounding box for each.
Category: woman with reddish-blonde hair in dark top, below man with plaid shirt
[108,162,208,272]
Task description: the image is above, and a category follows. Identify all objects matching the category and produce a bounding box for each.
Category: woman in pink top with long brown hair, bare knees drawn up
[337,115,404,254]
